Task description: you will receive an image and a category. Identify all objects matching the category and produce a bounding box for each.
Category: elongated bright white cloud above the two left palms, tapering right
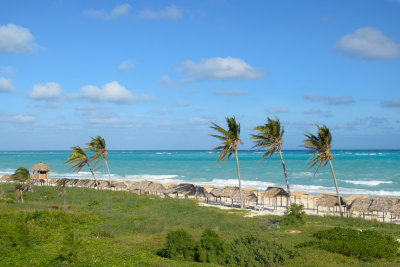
[80,81,156,104]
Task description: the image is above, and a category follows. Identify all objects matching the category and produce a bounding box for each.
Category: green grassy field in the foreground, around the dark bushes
[0,184,400,266]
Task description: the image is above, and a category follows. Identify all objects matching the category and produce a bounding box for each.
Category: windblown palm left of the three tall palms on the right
[210,117,243,208]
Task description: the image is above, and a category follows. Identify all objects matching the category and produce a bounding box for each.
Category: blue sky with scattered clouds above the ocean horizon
[0,0,400,150]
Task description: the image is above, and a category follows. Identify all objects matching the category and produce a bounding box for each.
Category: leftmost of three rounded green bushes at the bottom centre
[161,229,196,260]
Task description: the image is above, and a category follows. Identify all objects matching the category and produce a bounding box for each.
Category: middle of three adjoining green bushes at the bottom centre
[196,229,229,264]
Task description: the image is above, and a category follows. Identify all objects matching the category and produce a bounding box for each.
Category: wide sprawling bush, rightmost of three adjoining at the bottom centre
[227,234,297,266]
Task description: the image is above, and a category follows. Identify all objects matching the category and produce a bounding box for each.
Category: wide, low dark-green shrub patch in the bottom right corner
[315,227,400,261]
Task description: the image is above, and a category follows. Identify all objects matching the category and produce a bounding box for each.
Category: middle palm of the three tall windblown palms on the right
[251,117,291,203]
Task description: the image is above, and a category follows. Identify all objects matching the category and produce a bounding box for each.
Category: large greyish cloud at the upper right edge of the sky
[333,27,400,59]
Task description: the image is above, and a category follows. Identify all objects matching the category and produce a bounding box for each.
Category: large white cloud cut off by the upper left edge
[0,24,35,54]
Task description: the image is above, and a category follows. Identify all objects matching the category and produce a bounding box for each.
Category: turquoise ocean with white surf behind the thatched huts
[0,150,400,197]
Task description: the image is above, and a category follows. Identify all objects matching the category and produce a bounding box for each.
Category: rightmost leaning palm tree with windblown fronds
[303,124,343,216]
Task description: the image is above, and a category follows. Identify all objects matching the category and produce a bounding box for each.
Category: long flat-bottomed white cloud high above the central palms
[178,57,265,80]
